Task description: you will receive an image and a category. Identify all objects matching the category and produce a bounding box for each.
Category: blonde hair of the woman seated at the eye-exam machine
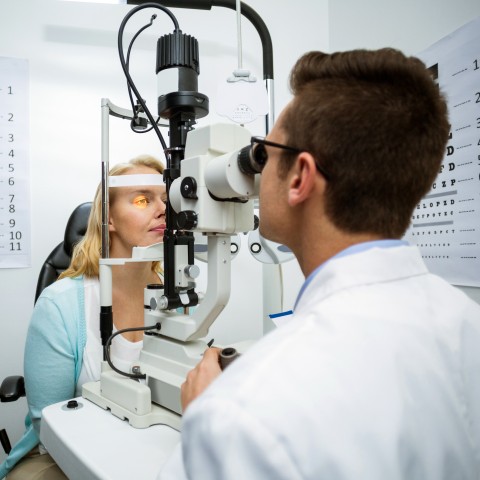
[58,155,164,280]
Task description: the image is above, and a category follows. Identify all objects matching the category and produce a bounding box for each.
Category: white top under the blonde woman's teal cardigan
[75,278,143,396]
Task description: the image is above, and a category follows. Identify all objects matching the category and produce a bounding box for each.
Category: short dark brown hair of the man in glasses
[281,49,450,238]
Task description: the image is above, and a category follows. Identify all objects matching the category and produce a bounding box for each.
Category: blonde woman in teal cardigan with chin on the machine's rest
[0,155,166,480]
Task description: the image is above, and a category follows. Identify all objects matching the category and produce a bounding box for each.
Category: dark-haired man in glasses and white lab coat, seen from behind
[158,49,480,480]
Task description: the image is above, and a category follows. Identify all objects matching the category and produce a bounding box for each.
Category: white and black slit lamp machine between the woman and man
[82,0,291,430]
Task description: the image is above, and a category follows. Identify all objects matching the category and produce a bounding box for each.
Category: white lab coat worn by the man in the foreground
[159,246,480,480]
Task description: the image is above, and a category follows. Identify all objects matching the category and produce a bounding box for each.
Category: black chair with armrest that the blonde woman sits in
[0,202,92,455]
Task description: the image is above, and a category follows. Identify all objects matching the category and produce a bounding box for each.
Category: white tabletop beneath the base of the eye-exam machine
[40,397,180,480]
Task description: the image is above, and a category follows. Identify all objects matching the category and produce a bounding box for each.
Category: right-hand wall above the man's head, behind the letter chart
[329,0,480,303]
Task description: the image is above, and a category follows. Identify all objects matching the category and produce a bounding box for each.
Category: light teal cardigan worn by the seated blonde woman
[0,277,87,479]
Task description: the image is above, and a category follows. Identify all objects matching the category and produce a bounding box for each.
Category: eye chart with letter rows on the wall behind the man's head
[405,18,480,287]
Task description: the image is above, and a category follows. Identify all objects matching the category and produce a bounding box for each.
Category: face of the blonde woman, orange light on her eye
[109,166,166,258]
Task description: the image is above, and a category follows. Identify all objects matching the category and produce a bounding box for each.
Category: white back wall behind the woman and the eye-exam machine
[0,0,328,461]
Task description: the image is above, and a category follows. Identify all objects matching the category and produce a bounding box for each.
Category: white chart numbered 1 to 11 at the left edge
[0,57,31,268]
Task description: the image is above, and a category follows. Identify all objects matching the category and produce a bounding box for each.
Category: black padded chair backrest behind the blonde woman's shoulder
[35,202,92,302]
